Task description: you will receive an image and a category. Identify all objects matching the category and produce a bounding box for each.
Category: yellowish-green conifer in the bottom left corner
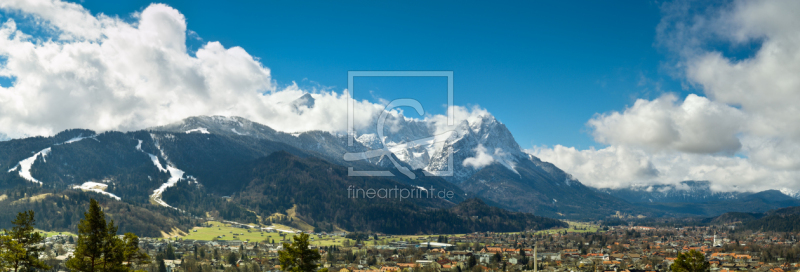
[2,211,50,272]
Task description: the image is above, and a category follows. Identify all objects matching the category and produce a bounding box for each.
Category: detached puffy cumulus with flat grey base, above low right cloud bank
[588,94,744,154]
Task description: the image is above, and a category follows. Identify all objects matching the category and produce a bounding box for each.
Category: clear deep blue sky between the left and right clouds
[67,0,691,149]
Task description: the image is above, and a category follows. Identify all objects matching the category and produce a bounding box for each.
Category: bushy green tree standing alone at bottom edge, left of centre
[278,233,327,272]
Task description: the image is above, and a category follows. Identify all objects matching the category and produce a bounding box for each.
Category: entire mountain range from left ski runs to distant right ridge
[0,92,800,236]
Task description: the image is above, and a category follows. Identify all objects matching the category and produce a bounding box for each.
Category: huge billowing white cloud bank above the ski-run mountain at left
[0,0,404,138]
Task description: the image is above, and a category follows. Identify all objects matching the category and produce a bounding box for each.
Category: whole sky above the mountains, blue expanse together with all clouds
[0,0,800,191]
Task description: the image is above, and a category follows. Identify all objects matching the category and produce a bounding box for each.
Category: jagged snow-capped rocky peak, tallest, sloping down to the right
[340,106,639,218]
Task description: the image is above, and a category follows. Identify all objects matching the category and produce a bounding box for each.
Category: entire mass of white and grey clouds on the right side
[528,0,800,191]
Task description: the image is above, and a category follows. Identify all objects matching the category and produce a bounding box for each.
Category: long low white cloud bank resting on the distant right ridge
[527,145,800,191]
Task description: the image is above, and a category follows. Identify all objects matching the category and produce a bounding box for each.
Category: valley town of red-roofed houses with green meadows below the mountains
[36,222,800,272]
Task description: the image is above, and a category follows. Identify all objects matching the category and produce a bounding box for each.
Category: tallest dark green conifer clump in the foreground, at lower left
[66,199,138,272]
